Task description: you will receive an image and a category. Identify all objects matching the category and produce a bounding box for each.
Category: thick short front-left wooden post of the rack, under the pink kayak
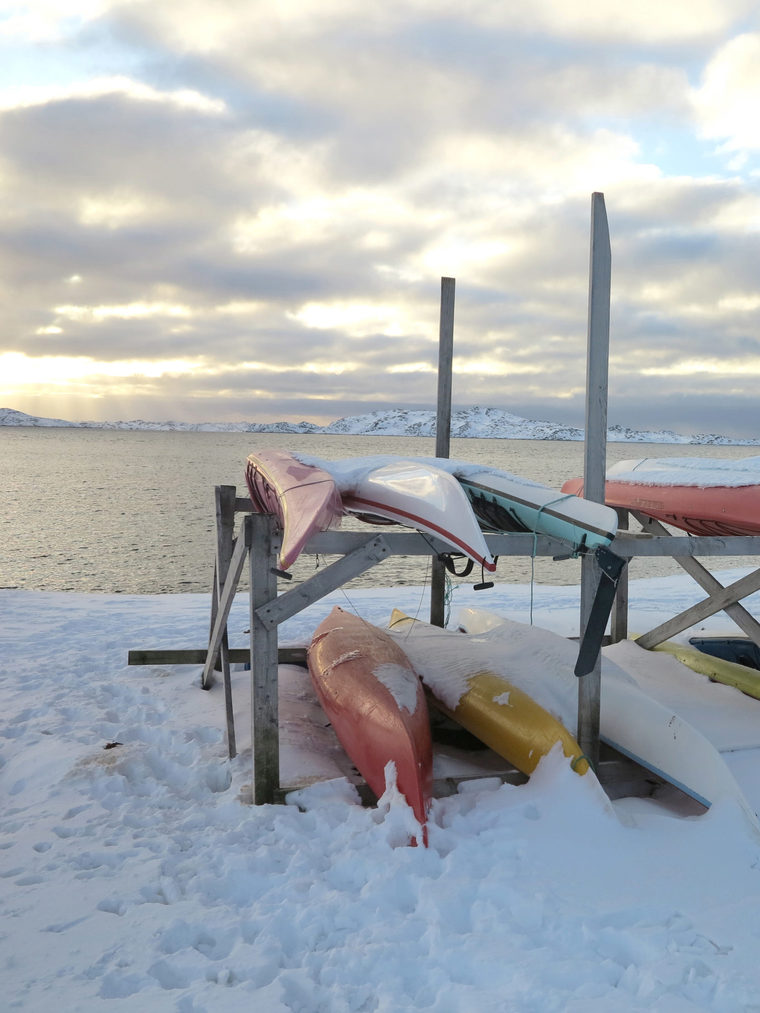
[251,514,280,805]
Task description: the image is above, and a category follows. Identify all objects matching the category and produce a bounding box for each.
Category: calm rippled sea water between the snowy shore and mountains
[0,426,749,594]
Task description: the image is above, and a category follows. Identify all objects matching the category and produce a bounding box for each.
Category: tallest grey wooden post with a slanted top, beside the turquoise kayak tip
[578,193,612,767]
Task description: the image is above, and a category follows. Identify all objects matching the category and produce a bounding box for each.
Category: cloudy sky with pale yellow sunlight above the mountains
[0,0,760,437]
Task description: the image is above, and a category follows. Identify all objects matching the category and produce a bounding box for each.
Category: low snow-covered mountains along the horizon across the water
[0,406,760,447]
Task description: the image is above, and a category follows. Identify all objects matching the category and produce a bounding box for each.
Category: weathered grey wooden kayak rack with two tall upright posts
[130,192,760,803]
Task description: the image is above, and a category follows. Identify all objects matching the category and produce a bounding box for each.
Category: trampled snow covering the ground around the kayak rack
[0,571,760,1013]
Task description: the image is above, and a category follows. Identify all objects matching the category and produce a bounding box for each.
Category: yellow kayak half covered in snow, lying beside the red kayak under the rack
[388,609,589,774]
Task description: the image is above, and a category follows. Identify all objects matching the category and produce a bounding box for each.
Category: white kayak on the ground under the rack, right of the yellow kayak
[458,609,760,831]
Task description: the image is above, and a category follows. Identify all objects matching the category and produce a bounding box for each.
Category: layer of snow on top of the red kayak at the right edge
[607,457,760,489]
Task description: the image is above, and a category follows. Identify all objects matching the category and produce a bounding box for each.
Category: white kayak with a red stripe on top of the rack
[300,456,497,571]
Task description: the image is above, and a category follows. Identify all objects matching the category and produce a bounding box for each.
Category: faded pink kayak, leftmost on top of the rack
[245,450,343,570]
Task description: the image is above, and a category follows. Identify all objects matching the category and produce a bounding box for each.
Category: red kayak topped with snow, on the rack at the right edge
[562,457,760,535]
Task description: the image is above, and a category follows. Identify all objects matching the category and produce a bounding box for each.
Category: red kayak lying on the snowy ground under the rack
[307,606,433,844]
